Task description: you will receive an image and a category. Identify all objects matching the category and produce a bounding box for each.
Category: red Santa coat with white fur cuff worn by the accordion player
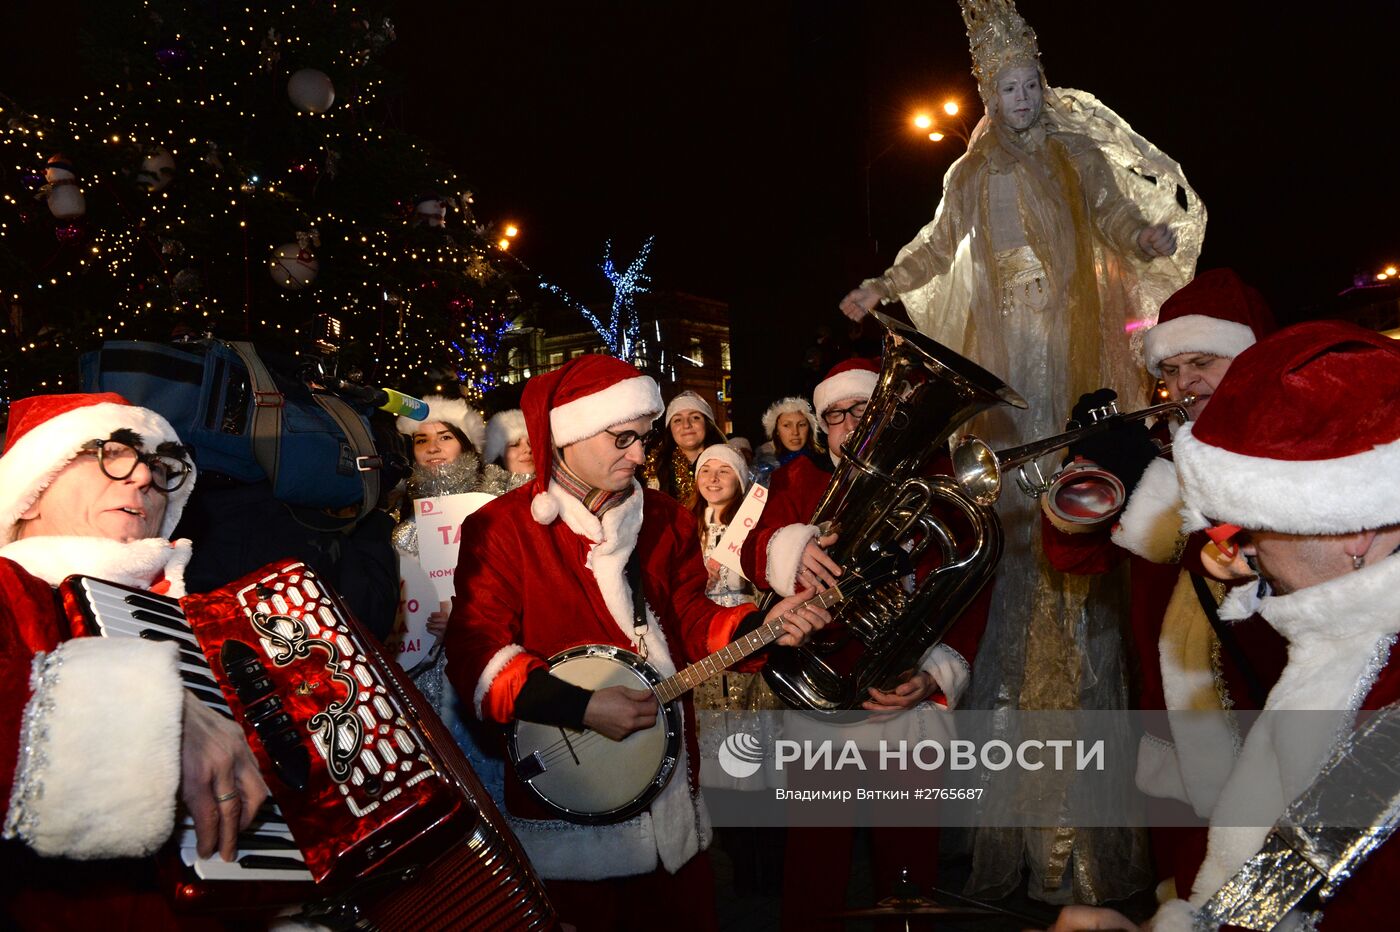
[0,537,196,929]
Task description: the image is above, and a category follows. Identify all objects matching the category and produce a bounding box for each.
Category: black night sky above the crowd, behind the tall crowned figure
[0,0,1400,423]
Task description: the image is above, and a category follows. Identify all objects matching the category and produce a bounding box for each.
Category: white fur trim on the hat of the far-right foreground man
[1172,424,1400,535]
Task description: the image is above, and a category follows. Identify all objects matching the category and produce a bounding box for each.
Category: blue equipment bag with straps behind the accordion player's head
[81,340,379,518]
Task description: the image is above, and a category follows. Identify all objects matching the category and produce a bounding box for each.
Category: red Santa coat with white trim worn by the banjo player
[445,483,755,880]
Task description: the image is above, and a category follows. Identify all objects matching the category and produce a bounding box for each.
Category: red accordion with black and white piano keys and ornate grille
[60,561,556,929]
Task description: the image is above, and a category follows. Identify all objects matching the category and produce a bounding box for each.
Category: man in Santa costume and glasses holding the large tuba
[741,358,991,929]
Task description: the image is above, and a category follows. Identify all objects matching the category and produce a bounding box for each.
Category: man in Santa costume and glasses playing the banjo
[447,355,827,929]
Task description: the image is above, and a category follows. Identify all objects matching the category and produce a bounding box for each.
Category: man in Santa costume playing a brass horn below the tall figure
[1040,269,1285,898]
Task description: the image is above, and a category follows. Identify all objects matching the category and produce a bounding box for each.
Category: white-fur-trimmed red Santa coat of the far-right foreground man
[1152,554,1400,932]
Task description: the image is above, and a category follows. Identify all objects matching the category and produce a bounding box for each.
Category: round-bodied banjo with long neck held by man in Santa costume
[507,553,899,824]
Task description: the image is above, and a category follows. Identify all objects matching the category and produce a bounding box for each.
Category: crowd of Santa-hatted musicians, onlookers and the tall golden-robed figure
[0,0,1400,932]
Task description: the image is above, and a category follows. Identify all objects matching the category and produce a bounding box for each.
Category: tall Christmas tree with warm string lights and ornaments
[0,0,521,402]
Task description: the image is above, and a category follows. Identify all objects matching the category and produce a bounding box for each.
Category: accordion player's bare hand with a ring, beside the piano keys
[181,691,267,861]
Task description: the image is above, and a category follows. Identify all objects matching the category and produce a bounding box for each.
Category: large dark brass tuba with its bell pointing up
[763,312,1026,711]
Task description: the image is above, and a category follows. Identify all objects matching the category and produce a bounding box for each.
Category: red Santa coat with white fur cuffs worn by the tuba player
[739,455,991,708]
